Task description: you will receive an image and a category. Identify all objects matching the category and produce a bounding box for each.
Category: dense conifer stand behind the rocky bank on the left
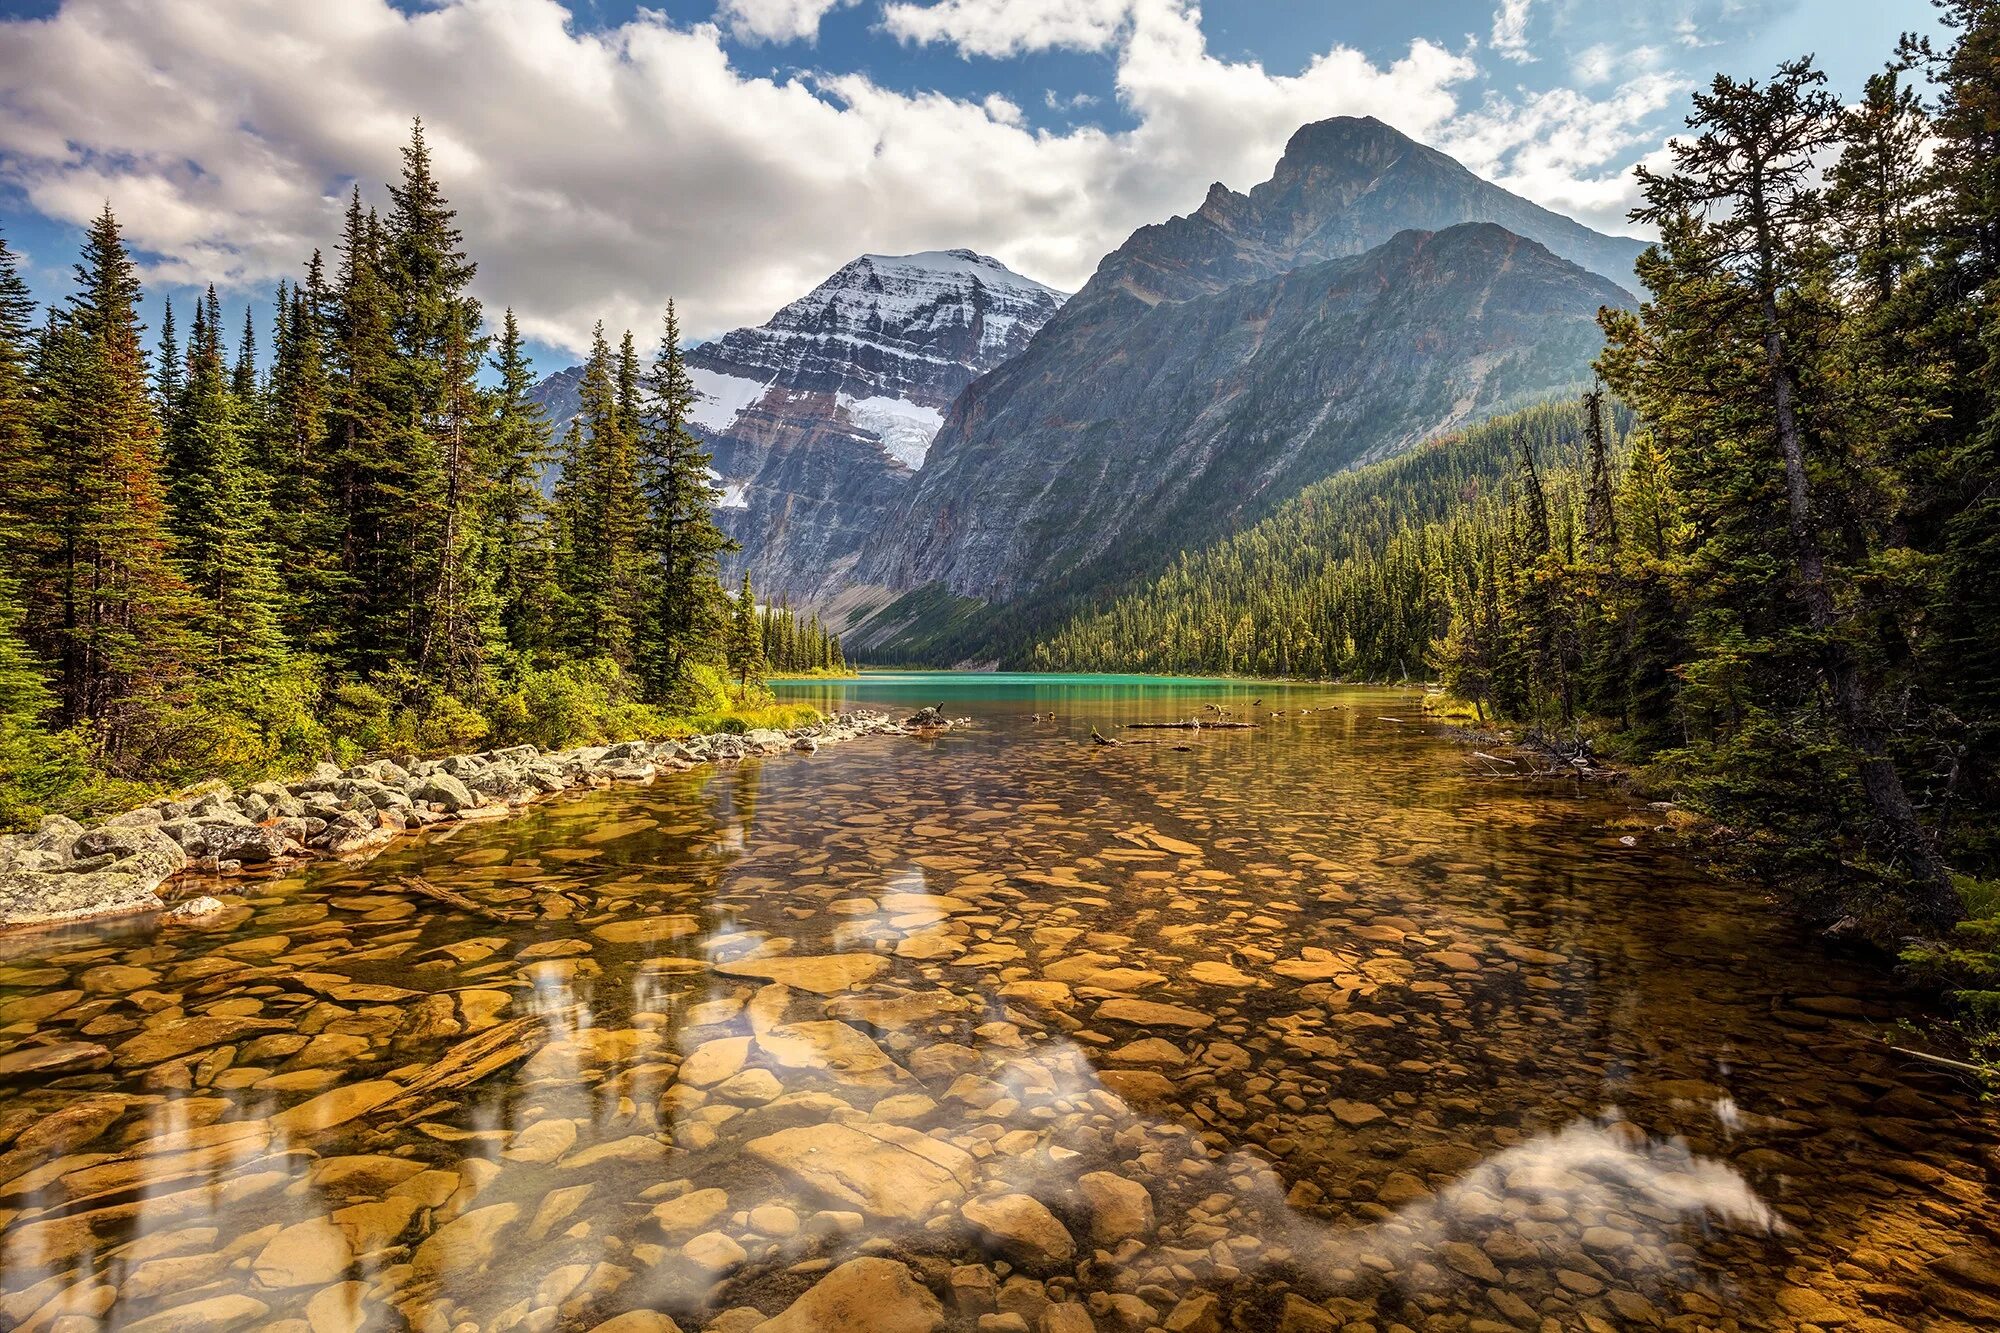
[0,124,840,825]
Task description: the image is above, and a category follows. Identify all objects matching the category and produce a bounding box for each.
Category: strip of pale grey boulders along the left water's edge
[0,711,920,929]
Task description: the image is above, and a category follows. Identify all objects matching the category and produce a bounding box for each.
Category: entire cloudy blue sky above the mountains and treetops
[0,0,1934,368]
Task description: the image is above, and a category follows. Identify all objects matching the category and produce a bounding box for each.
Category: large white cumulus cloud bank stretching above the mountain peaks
[0,0,1646,348]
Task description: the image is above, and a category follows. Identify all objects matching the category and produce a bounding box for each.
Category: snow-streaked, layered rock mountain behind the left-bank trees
[536,250,1064,600]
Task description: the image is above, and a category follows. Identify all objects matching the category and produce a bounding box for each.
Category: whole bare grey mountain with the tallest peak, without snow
[854,118,1644,604]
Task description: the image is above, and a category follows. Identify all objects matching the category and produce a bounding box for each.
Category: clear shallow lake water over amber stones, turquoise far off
[0,675,2000,1333]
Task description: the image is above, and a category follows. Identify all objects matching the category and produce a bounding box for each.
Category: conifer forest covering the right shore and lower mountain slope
[1032,10,2000,1048]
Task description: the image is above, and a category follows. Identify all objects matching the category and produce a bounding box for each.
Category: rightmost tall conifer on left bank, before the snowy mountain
[638,302,736,701]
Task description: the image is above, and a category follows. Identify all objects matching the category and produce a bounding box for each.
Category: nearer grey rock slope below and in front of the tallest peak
[858,222,1628,600]
